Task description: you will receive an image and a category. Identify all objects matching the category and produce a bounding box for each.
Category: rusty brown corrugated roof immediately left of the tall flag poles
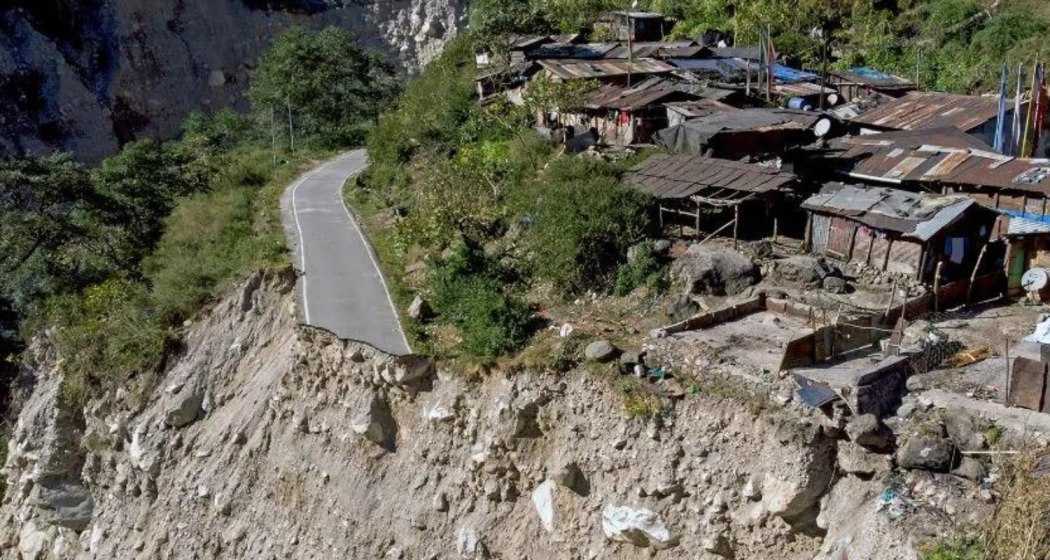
[852,92,999,130]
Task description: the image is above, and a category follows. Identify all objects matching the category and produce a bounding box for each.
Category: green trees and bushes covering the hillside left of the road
[0,28,397,402]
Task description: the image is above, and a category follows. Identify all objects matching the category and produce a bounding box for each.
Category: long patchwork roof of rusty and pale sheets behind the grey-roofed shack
[833,130,1050,195]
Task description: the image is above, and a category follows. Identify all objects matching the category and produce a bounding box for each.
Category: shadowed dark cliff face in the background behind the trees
[0,0,466,161]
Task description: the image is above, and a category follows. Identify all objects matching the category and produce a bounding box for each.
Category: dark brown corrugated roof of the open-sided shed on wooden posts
[625,153,796,199]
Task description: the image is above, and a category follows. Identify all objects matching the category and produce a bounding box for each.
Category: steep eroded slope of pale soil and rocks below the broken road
[0,273,989,560]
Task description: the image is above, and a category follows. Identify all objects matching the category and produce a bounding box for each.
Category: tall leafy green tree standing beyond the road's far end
[248,27,398,146]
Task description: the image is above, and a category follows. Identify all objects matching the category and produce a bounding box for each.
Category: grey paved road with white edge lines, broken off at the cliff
[280,150,412,355]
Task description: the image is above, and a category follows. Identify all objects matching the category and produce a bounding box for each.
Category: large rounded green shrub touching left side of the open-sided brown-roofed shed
[517,157,651,294]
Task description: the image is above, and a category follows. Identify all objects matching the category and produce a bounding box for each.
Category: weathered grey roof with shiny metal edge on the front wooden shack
[802,184,977,242]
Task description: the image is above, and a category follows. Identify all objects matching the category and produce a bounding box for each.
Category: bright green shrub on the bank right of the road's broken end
[429,244,532,357]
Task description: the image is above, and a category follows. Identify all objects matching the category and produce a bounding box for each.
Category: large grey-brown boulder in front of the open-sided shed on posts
[671,245,759,295]
